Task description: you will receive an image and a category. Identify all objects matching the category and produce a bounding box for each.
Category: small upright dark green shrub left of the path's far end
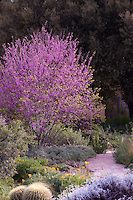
[90,125,108,153]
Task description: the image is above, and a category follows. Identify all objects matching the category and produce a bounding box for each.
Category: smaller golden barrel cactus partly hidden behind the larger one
[9,185,26,200]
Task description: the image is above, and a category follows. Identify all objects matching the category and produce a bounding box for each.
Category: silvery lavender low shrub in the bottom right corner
[59,175,133,200]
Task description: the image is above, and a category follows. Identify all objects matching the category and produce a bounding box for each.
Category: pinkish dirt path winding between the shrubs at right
[87,151,130,179]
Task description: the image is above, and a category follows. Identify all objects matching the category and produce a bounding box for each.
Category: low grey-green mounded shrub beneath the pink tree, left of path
[36,145,96,164]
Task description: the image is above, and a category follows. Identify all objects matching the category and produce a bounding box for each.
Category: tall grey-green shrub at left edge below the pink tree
[0,116,31,178]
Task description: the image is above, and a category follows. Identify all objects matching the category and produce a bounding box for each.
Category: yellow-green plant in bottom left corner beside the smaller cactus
[0,178,14,200]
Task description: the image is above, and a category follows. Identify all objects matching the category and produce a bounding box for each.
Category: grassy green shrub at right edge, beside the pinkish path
[115,137,133,166]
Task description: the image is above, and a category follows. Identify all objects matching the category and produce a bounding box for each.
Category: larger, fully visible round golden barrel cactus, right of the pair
[22,182,52,200]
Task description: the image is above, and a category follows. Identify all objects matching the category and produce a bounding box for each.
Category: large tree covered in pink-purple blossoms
[0,27,104,143]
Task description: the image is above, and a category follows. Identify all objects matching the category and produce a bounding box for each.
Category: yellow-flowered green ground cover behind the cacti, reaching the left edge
[0,157,91,197]
